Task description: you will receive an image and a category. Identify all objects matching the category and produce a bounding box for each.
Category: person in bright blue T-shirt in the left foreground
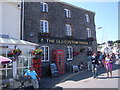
[24,67,40,90]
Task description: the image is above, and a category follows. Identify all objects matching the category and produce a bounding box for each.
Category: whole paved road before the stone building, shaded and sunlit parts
[10,65,120,90]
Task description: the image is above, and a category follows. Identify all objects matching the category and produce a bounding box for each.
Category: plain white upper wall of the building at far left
[0,2,21,39]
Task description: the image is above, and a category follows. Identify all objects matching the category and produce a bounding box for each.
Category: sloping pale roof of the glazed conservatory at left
[0,35,39,46]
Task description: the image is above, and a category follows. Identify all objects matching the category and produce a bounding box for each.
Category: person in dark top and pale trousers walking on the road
[91,53,99,78]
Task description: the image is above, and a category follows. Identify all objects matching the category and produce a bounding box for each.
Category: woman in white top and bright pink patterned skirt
[105,54,113,77]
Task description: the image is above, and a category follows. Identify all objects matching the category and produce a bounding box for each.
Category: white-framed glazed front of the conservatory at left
[0,48,32,80]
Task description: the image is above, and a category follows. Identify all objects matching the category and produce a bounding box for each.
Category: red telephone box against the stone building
[52,50,65,74]
